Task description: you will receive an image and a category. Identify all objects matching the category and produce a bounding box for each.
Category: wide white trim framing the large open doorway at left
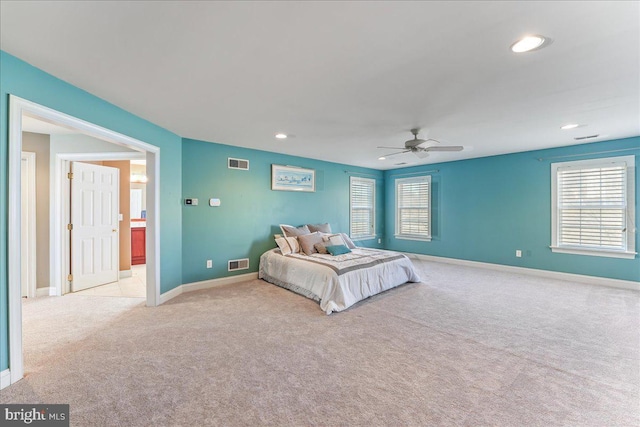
[7,95,160,384]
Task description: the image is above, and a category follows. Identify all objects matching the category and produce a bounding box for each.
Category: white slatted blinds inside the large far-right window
[557,162,627,250]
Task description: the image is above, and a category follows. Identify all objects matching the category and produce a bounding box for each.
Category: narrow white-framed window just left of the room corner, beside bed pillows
[349,176,376,240]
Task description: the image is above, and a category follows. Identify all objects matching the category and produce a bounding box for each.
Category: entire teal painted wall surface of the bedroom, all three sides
[0,48,640,380]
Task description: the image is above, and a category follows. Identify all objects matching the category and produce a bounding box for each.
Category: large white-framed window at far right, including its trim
[551,156,635,258]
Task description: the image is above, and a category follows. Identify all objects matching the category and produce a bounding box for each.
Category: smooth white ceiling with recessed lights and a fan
[0,0,640,169]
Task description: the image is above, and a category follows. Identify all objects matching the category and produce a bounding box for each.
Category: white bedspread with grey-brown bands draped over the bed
[258,248,420,314]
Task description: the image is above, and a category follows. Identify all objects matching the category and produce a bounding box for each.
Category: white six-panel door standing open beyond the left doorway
[71,162,120,292]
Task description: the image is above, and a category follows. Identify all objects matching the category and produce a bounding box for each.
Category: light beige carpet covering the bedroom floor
[0,261,640,426]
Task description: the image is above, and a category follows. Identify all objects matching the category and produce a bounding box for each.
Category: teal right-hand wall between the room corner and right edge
[385,137,640,281]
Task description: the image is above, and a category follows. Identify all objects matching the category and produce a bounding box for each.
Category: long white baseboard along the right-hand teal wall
[406,252,640,291]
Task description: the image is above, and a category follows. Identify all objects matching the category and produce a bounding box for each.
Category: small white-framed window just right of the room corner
[396,176,431,241]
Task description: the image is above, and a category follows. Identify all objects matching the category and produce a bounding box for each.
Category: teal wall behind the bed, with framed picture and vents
[182,139,384,283]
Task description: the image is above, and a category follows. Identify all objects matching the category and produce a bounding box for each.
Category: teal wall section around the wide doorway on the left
[0,51,182,371]
